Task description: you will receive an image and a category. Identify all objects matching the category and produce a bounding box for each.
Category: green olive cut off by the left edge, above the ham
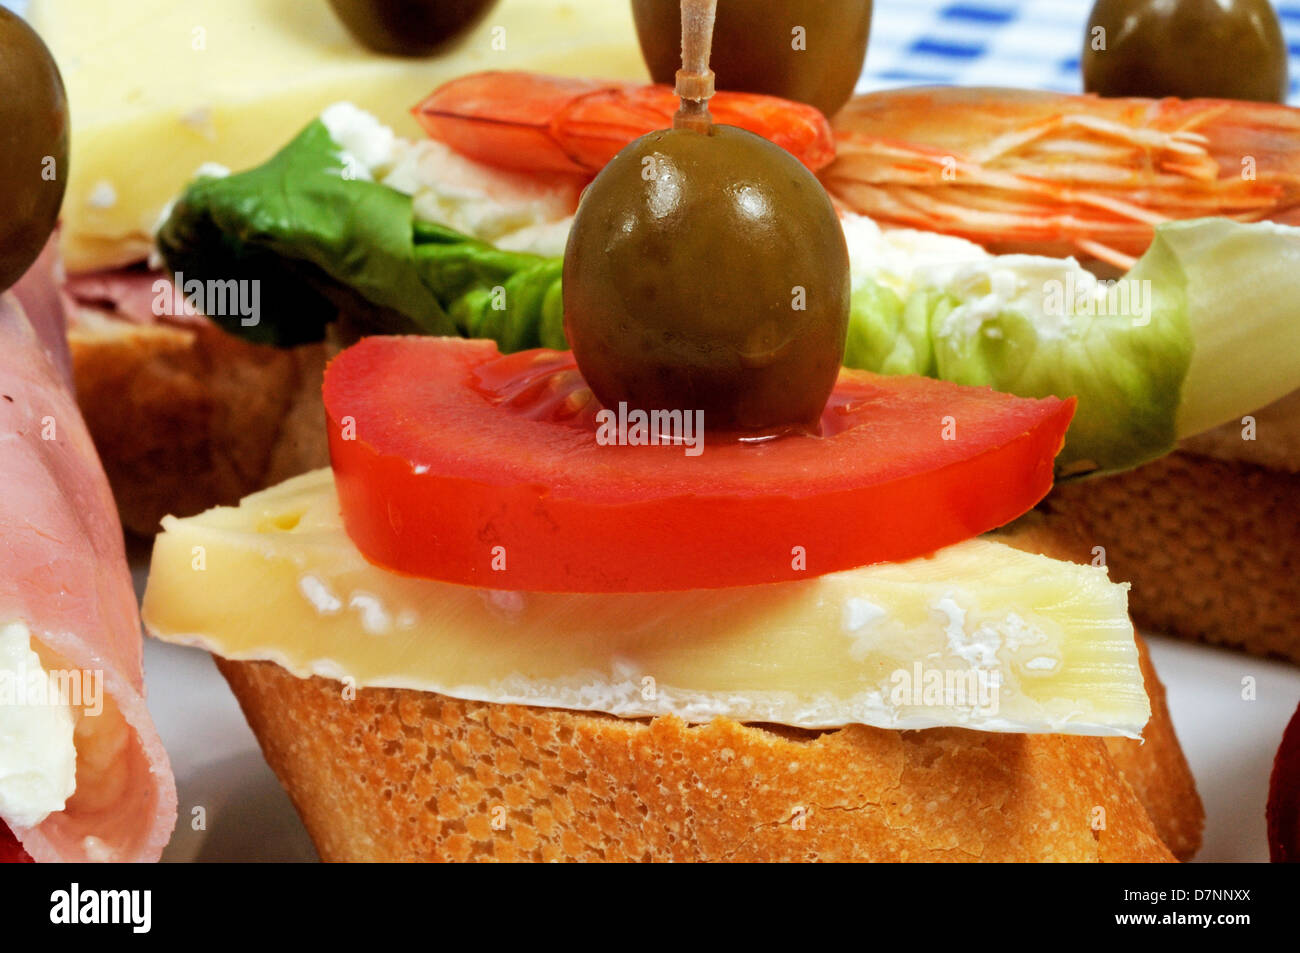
[0,7,68,291]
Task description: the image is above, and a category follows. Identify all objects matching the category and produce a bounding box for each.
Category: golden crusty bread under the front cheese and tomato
[217,659,1173,862]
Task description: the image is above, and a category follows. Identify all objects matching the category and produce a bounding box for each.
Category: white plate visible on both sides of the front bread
[133,554,1300,862]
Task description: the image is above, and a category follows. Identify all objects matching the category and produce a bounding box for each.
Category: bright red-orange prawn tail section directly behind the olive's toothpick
[412,73,835,176]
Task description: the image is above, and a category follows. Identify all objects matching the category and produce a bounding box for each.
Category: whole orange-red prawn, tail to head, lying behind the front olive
[415,73,1300,268]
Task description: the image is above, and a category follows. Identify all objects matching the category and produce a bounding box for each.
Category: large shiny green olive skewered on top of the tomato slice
[563,126,849,433]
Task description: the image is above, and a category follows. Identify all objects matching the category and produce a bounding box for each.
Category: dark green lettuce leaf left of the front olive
[157,120,563,351]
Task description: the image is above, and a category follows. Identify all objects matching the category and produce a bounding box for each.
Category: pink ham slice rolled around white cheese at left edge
[0,254,177,861]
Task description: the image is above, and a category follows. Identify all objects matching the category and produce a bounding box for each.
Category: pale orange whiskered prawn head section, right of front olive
[822,87,1300,267]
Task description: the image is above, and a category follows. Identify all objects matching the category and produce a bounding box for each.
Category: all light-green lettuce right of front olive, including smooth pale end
[845,218,1300,477]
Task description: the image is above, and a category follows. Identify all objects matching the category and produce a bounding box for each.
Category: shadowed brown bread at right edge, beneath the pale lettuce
[1040,451,1300,663]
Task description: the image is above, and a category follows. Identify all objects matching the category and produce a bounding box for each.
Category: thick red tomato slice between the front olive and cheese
[324,337,1074,593]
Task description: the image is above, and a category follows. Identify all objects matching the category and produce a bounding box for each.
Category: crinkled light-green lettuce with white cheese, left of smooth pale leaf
[845,248,1191,475]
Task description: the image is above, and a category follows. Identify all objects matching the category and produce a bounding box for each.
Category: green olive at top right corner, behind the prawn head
[1083,0,1287,103]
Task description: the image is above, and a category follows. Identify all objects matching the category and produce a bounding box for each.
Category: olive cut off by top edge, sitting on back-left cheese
[329,0,497,56]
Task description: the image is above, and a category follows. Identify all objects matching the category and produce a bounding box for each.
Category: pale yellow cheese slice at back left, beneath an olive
[27,0,646,272]
